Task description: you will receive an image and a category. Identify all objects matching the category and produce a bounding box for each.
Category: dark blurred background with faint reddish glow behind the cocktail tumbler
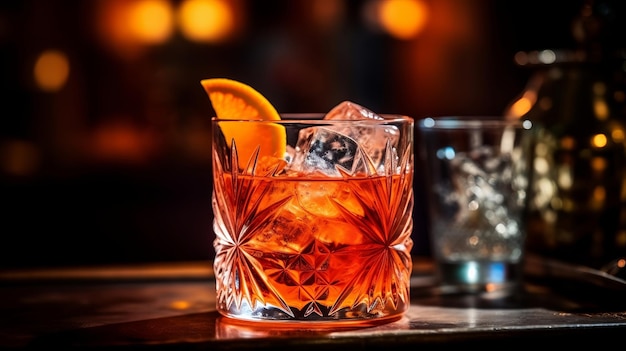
[0,0,582,268]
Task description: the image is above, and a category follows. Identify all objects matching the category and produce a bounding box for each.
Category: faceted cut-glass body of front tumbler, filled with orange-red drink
[212,115,413,322]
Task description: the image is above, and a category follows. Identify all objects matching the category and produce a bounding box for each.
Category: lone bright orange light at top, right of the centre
[378,0,428,39]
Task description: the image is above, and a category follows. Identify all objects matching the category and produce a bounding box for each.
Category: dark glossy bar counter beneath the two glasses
[0,258,626,350]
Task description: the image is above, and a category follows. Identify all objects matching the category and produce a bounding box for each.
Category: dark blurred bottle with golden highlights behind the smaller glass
[505,1,626,268]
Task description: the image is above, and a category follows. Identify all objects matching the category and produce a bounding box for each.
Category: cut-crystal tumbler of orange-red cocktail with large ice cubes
[212,102,414,327]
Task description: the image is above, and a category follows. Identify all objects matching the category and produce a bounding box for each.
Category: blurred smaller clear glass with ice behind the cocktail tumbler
[418,117,531,294]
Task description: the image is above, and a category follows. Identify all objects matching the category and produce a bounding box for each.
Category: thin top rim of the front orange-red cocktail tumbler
[211,112,415,125]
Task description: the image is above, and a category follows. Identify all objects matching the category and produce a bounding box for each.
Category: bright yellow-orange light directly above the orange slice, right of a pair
[178,0,235,42]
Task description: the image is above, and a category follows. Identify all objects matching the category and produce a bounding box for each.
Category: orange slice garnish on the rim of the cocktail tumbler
[200,78,287,169]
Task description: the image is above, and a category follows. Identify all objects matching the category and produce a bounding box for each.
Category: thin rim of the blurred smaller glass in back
[417,115,532,130]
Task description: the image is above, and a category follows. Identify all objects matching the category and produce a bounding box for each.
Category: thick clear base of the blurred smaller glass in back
[437,261,522,294]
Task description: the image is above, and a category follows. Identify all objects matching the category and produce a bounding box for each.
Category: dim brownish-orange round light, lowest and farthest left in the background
[33,50,70,92]
